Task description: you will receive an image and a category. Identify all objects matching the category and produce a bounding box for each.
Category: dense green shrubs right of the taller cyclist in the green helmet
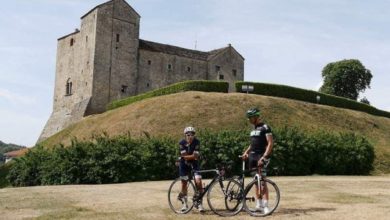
[271,128,375,175]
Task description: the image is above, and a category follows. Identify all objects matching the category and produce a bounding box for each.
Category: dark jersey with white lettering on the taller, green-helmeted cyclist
[250,123,272,154]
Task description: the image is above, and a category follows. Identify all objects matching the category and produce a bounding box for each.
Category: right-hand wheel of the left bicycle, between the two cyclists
[207,179,244,216]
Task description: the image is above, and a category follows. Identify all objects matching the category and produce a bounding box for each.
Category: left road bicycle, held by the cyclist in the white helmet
[168,158,244,216]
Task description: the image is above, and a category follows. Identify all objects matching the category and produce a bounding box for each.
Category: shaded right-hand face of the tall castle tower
[89,0,140,114]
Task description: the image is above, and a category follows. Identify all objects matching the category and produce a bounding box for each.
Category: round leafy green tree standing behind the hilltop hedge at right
[320,59,372,100]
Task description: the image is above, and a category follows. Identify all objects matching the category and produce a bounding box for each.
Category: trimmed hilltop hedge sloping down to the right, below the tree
[236,82,390,118]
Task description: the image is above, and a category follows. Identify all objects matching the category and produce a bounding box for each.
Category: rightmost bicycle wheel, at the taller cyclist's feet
[244,179,280,216]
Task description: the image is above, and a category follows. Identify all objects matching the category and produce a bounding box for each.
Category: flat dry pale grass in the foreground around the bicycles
[0,176,390,220]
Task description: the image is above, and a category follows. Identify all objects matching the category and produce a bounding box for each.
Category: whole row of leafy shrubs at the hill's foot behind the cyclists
[8,128,374,186]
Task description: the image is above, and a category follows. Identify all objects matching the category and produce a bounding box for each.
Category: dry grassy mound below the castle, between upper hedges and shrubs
[43,92,390,173]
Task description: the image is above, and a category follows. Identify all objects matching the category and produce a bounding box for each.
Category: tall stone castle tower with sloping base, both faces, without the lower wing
[38,0,140,142]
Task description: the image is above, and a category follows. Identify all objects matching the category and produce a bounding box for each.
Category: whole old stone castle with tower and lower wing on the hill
[38,0,244,142]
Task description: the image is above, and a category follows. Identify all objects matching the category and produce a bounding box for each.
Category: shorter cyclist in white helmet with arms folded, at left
[179,127,204,212]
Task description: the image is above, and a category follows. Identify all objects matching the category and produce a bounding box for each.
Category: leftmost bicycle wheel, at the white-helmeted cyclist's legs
[168,178,195,214]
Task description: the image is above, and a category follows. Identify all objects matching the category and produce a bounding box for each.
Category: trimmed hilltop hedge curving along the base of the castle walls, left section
[107,80,229,110]
